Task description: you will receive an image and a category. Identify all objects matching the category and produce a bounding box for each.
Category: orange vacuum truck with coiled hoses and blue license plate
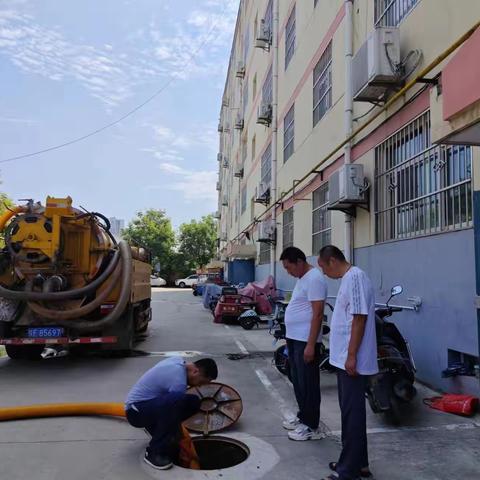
[0,197,151,359]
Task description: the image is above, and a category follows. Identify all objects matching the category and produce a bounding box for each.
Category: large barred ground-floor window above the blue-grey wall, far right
[375,112,472,243]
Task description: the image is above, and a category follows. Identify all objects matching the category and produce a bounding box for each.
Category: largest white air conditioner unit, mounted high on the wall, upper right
[352,27,401,102]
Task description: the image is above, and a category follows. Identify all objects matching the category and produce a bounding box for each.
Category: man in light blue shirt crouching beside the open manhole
[125,357,218,470]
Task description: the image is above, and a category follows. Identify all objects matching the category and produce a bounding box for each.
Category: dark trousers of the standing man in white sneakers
[287,338,320,430]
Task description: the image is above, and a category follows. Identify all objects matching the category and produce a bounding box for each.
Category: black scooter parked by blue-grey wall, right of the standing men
[366,285,417,424]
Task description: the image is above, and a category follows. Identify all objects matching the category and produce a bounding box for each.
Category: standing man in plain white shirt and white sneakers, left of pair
[280,247,327,440]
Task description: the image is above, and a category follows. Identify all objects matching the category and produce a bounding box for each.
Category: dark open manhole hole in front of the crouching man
[177,436,250,470]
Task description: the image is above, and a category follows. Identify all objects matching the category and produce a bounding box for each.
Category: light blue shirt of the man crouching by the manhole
[125,357,187,409]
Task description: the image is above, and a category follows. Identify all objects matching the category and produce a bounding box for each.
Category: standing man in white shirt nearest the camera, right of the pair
[318,245,378,480]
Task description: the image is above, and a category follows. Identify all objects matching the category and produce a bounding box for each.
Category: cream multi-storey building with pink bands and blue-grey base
[217,0,480,392]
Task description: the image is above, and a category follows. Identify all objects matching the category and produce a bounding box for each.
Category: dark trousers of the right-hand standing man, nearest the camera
[337,369,368,480]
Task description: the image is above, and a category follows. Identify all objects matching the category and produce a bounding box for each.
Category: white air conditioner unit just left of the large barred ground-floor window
[328,163,365,209]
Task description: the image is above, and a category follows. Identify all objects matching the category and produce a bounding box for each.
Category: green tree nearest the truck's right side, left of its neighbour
[122,209,175,275]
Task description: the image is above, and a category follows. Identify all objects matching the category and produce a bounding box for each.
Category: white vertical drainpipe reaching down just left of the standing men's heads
[270,0,279,278]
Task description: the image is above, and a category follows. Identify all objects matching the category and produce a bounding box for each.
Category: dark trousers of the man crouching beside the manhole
[126,392,200,457]
